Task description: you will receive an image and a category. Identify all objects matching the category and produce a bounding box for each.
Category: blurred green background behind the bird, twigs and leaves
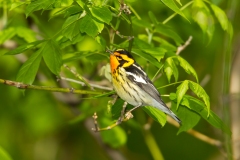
[0,0,240,160]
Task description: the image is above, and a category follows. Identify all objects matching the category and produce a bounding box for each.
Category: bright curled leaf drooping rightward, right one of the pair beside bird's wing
[189,81,210,116]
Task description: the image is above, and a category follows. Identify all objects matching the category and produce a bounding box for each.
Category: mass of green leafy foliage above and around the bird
[0,0,233,159]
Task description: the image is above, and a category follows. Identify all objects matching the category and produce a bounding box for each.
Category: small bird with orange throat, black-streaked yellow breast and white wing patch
[110,49,181,124]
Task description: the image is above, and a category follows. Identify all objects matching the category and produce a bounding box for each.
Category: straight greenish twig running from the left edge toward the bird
[0,79,103,94]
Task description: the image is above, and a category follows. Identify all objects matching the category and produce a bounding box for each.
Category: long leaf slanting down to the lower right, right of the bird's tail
[181,95,231,135]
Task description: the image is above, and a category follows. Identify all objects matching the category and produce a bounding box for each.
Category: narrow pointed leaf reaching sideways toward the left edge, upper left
[5,40,45,55]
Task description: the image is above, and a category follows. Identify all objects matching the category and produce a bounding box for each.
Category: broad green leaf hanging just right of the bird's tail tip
[171,101,201,134]
